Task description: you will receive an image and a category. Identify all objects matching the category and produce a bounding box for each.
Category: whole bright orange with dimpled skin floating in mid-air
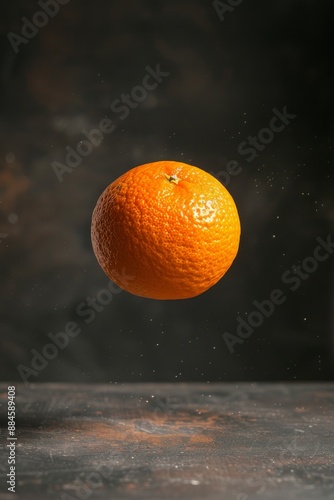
[91,161,240,300]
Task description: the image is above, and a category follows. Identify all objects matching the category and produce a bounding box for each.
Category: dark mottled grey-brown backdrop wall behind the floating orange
[0,0,334,383]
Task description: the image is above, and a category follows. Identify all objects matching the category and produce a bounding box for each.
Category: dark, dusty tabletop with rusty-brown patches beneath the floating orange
[0,383,334,500]
